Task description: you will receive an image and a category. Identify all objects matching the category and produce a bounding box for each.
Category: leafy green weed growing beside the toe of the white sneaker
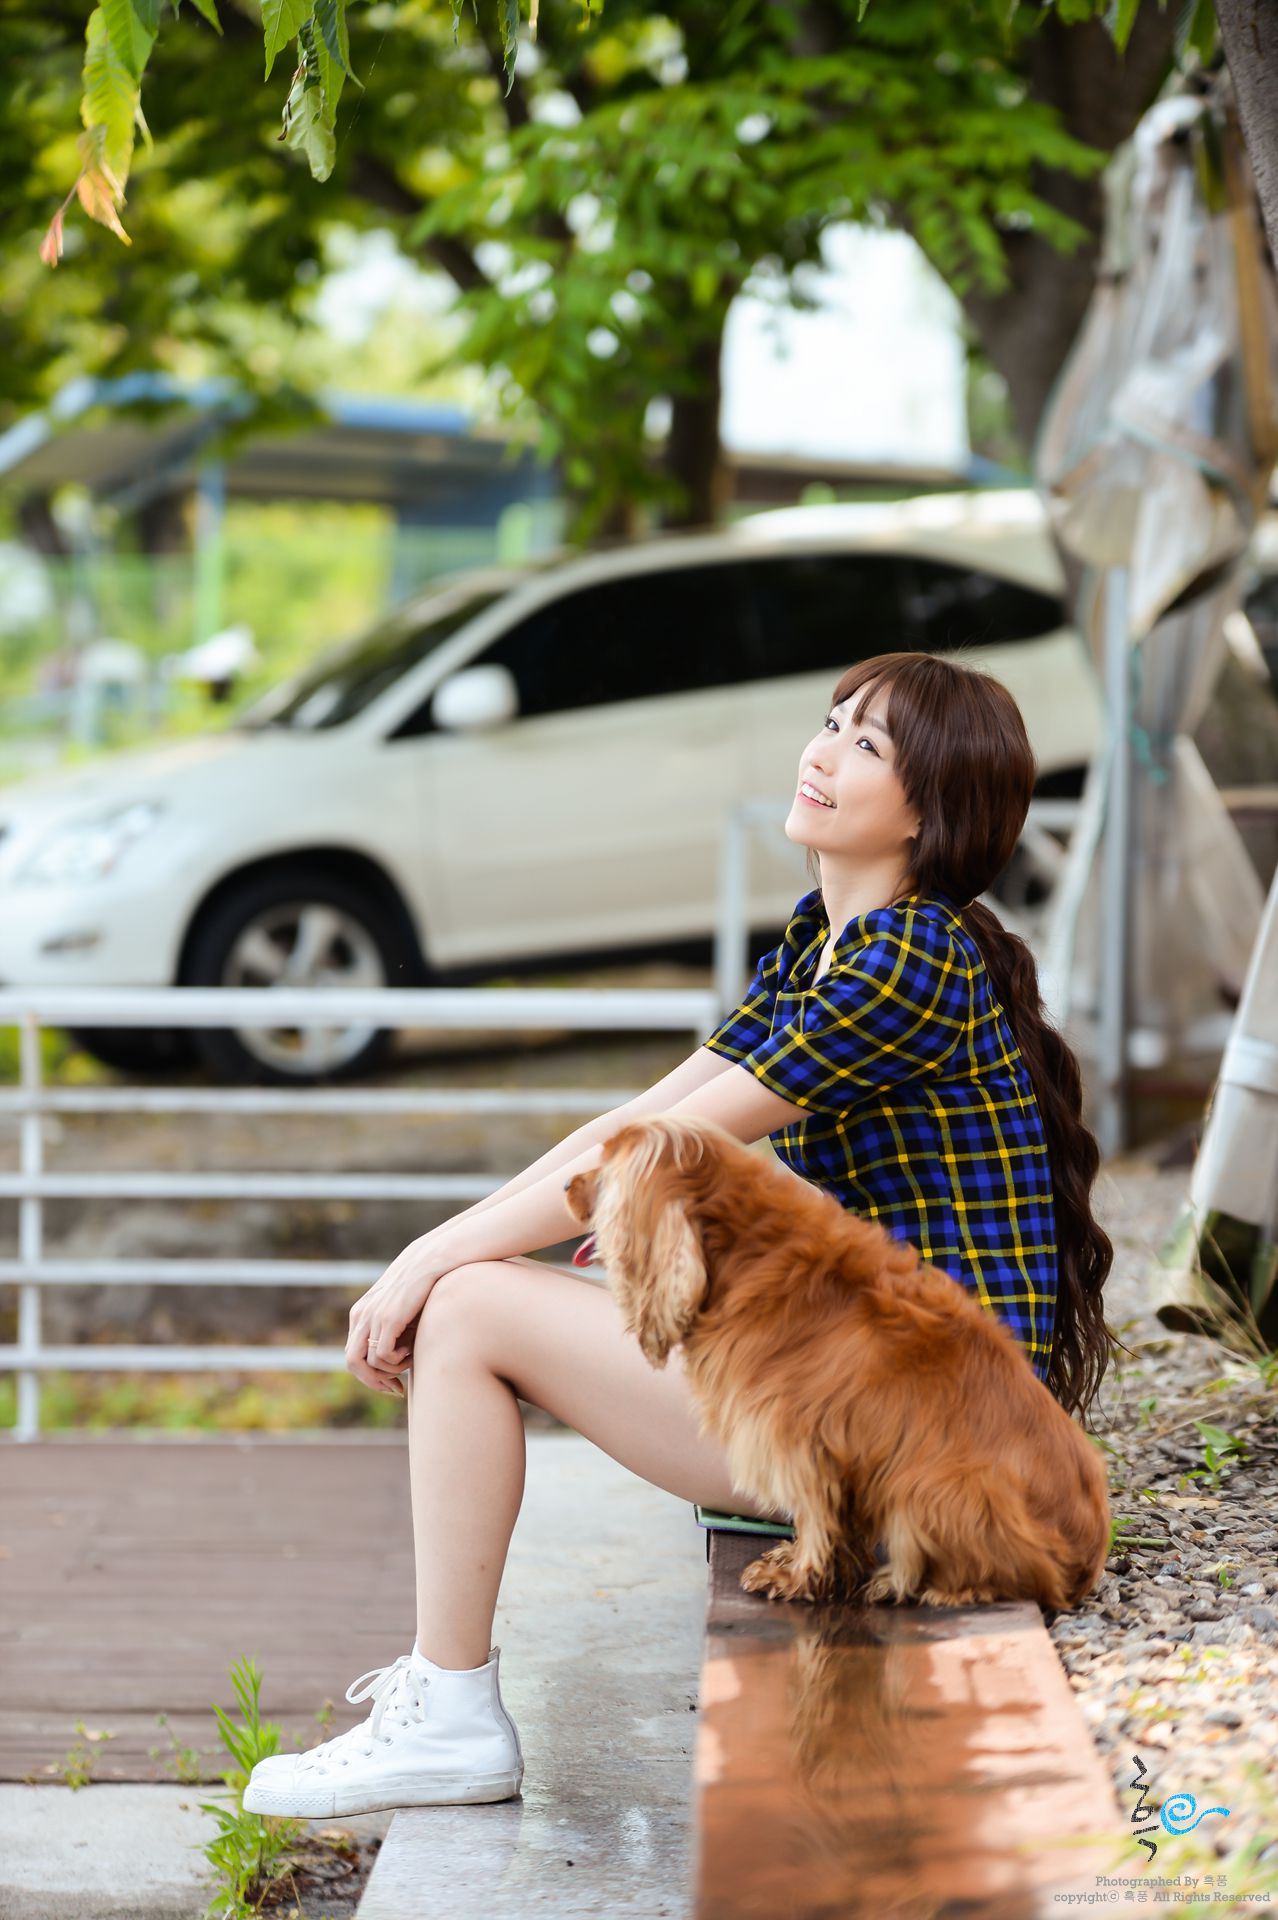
[200,1659,303,1920]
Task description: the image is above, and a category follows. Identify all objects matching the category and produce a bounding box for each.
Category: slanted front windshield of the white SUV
[240,589,507,732]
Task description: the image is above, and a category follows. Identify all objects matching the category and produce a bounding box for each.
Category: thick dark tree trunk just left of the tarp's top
[963,0,1174,457]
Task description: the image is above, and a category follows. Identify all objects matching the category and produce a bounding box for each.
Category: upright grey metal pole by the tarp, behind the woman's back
[1096,566,1132,1156]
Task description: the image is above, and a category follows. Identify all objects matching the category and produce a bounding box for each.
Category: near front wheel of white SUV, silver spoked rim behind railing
[182,870,414,1085]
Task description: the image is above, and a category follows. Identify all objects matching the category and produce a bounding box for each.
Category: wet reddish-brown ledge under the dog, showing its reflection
[695,1532,1132,1920]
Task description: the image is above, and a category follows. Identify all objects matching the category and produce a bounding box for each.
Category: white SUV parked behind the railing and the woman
[0,492,1101,1081]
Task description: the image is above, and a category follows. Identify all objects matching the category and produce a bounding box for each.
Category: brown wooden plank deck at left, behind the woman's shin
[0,1434,413,1782]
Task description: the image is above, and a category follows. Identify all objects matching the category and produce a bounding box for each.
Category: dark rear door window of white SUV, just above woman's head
[741,553,910,680]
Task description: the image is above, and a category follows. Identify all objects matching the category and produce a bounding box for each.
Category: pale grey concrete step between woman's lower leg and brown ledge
[359,1434,706,1920]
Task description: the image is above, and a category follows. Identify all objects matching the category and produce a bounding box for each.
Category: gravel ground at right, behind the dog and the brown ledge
[1048,1152,1278,1914]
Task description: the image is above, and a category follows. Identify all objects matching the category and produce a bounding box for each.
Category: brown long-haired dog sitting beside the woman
[566,1114,1109,1609]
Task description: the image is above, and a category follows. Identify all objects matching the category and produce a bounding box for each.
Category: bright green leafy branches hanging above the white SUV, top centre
[409,0,1105,536]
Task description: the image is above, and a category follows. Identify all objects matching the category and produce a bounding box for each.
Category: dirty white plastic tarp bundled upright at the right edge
[1034,71,1278,1336]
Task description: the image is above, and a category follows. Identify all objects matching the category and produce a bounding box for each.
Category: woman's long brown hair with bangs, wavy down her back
[808,653,1123,1427]
